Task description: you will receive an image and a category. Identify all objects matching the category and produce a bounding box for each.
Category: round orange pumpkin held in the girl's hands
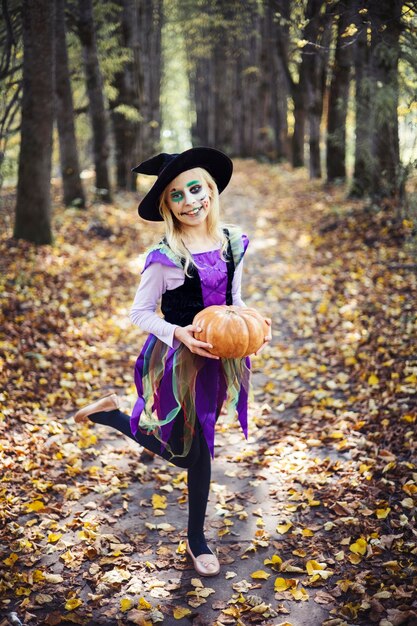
[193,305,269,359]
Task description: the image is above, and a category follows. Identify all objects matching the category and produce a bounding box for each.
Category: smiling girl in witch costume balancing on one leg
[74,148,271,576]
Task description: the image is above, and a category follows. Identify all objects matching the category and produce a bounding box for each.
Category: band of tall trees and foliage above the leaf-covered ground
[0,0,417,243]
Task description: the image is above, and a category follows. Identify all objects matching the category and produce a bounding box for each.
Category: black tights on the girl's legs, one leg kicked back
[89,409,211,556]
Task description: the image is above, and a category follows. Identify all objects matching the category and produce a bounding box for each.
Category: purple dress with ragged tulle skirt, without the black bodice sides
[131,236,250,457]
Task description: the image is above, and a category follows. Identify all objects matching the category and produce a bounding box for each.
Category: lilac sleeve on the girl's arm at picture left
[129,263,179,348]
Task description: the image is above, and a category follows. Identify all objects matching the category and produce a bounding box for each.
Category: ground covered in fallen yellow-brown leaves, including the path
[0,161,417,626]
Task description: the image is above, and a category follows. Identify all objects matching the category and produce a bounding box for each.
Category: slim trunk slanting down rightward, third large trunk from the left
[78,0,111,202]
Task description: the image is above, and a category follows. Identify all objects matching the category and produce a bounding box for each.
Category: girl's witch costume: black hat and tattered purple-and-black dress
[130,148,250,462]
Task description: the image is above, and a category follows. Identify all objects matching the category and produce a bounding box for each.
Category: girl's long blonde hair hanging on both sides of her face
[159,167,227,276]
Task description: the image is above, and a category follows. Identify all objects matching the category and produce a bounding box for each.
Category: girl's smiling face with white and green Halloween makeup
[168,170,210,224]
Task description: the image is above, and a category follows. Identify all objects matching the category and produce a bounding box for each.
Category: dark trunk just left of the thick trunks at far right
[326,0,353,182]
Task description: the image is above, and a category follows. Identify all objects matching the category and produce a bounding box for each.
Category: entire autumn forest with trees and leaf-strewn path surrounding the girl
[0,0,417,626]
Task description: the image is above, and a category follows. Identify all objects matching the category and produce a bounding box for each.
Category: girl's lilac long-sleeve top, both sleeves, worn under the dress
[129,248,245,348]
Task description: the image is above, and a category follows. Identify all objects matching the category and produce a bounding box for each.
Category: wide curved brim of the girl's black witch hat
[132,148,233,222]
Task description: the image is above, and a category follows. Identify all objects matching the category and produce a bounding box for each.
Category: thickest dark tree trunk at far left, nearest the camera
[13,0,55,244]
